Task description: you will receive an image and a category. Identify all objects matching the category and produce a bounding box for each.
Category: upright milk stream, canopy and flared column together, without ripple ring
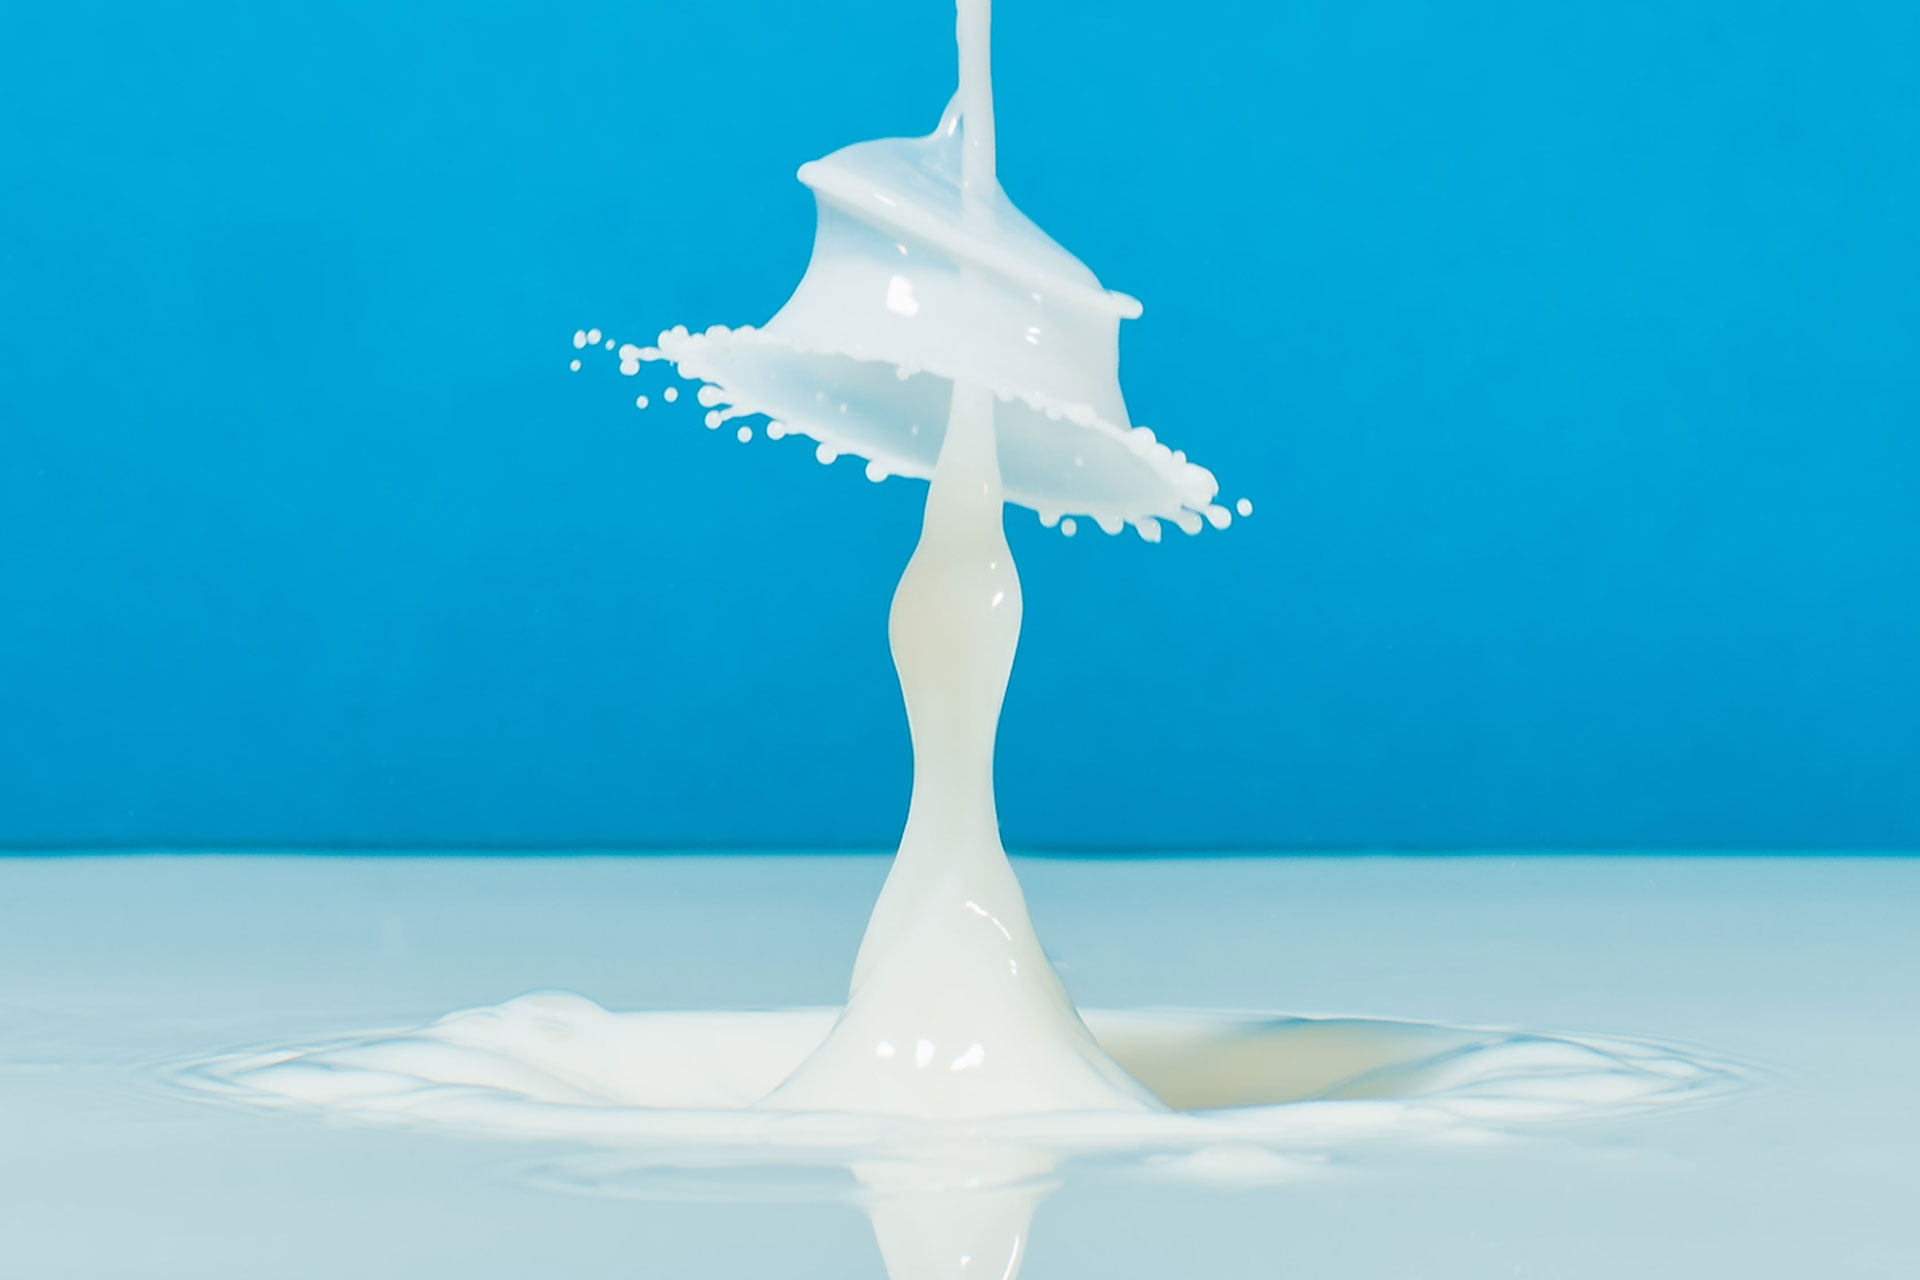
[637,0,1225,1117]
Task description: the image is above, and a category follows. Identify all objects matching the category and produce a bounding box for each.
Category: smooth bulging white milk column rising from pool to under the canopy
[766,384,1160,1115]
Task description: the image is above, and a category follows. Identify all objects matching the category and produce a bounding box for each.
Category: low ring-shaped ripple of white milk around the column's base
[180,992,1747,1143]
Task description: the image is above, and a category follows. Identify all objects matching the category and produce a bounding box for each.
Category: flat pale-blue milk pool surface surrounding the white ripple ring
[0,856,1920,1280]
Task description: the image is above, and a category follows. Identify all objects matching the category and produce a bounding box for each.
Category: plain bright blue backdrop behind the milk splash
[0,0,1920,848]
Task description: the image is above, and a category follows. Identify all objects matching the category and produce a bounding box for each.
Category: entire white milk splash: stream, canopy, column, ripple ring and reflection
[182,0,1738,1280]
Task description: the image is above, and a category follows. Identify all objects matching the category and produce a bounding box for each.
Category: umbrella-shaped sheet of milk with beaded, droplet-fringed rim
[645,100,1227,537]
